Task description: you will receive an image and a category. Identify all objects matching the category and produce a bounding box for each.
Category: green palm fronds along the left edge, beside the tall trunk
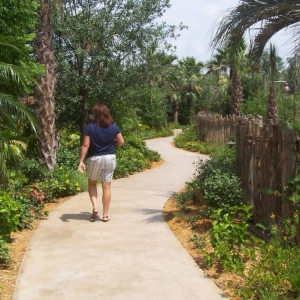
[0,36,36,189]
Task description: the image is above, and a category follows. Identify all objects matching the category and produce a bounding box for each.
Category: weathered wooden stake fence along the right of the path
[197,113,299,224]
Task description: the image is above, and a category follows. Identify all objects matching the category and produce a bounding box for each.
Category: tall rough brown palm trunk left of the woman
[36,0,58,171]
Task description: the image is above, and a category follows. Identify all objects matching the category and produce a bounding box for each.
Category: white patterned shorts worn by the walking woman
[88,154,116,182]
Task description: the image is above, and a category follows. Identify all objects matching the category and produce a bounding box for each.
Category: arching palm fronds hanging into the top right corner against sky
[210,0,300,58]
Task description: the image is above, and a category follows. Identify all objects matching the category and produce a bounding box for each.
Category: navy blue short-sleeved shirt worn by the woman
[84,123,121,157]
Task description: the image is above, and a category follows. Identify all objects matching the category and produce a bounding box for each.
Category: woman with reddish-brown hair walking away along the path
[78,105,124,222]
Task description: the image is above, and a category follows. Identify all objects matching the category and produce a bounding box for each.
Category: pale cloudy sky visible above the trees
[162,0,293,62]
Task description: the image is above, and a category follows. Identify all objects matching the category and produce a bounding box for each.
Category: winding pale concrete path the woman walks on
[13,137,226,300]
